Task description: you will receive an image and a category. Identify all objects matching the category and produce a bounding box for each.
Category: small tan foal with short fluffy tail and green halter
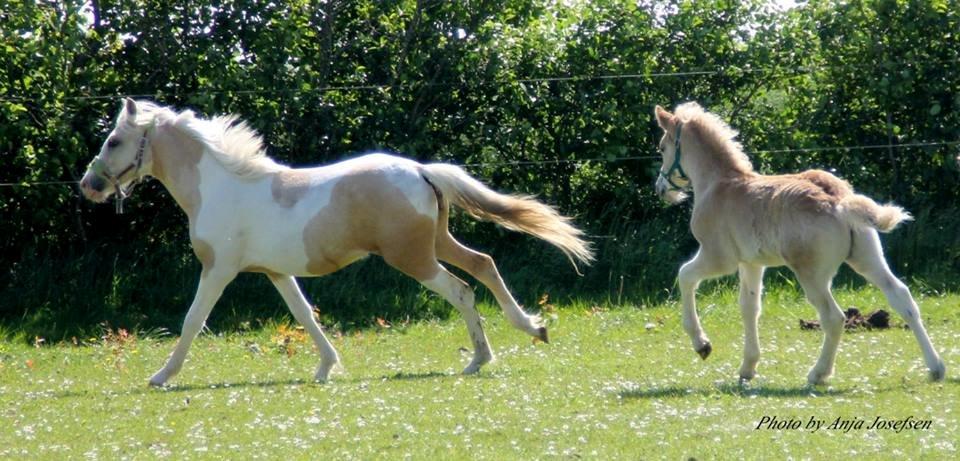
[656,102,945,384]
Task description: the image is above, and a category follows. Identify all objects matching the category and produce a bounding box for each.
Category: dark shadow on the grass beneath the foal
[617,384,850,400]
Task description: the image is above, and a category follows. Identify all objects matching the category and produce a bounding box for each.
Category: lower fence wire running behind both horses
[0,141,960,187]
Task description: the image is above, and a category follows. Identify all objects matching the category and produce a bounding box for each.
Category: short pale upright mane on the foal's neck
[674,102,753,173]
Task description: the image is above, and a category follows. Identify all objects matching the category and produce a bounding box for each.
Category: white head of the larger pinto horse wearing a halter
[80,98,153,210]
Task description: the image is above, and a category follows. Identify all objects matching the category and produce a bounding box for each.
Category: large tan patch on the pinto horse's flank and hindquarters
[303,171,439,281]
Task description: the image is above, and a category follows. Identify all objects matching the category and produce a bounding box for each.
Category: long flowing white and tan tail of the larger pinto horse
[420,163,594,273]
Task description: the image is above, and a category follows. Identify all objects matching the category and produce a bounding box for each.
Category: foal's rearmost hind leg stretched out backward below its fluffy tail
[847,229,946,381]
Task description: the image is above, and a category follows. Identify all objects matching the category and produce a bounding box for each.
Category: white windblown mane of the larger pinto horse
[124,101,284,179]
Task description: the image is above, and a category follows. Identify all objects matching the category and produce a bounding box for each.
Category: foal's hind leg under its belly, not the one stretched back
[795,271,846,384]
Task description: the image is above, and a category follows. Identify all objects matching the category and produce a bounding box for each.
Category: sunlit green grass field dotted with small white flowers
[0,289,960,459]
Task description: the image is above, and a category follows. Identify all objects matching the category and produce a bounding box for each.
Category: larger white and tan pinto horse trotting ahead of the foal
[80,99,593,386]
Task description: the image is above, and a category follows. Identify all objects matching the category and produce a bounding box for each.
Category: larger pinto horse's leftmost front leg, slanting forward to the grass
[150,269,236,386]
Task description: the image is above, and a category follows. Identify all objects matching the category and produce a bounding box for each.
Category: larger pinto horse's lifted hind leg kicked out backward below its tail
[437,234,548,342]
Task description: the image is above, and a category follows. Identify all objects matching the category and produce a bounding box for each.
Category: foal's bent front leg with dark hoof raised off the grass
[679,247,736,360]
